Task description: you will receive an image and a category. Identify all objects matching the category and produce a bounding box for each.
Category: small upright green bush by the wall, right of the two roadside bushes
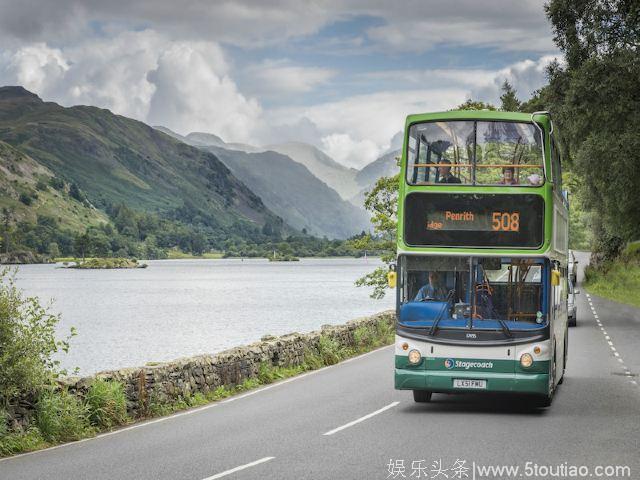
[85,379,128,429]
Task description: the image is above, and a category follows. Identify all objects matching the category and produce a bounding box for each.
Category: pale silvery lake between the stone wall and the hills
[12,258,395,375]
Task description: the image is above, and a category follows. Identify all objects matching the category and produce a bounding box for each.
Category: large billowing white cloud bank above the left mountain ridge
[0,30,261,141]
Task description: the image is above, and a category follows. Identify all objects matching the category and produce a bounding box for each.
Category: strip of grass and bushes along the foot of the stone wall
[0,320,394,457]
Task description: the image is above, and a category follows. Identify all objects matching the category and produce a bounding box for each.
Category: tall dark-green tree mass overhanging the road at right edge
[544,0,640,253]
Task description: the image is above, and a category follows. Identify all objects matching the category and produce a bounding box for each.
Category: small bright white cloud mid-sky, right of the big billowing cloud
[247,59,336,95]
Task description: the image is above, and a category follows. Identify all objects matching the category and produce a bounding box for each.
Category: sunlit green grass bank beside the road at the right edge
[585,255,640,307]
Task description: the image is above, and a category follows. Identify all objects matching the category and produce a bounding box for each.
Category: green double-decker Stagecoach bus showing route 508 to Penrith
[390,110,568,406]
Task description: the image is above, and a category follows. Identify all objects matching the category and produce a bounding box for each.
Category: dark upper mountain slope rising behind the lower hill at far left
[0,87,282,238]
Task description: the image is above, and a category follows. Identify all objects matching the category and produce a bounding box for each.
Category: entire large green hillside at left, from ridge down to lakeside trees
[0,87,300,257]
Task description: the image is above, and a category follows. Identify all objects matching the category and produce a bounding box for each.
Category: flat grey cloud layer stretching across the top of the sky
[0,0,555,52]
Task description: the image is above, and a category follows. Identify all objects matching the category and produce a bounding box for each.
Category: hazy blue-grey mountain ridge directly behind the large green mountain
[202,146,370,238]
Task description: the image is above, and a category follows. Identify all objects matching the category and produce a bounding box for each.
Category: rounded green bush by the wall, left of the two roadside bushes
[36,390,95,442]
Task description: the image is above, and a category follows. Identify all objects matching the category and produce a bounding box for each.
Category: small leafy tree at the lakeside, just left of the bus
[353,174,400,299]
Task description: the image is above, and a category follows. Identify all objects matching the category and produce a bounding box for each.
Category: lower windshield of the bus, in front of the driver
[398,256,547,333]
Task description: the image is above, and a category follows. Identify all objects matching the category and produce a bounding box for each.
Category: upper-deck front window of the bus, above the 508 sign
[407,120,544,186]
